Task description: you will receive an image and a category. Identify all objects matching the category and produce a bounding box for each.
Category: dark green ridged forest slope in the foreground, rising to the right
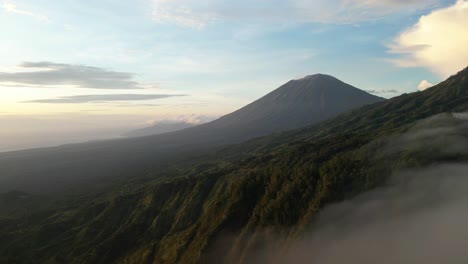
[0,69,468,263]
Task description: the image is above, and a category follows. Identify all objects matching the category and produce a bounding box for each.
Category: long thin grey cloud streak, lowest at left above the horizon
[24,94,186,104]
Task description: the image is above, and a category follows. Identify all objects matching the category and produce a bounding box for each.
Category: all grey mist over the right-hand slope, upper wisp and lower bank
[248,114,468,264]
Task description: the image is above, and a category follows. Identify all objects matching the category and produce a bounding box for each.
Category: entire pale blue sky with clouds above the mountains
[0,0,468,151]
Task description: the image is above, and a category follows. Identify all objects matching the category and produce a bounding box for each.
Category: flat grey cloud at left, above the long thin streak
[0,62,142,89]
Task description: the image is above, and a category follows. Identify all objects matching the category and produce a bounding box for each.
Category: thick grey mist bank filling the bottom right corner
[262,164,468,264]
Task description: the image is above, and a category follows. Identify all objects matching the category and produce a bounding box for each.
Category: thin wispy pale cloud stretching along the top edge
[152,0,441,29]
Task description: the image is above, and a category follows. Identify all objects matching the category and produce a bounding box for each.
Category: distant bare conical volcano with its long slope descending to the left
[0,75,383,193]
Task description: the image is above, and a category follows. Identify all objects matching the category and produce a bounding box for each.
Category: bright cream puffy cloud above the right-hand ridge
[389,0,468,77]
